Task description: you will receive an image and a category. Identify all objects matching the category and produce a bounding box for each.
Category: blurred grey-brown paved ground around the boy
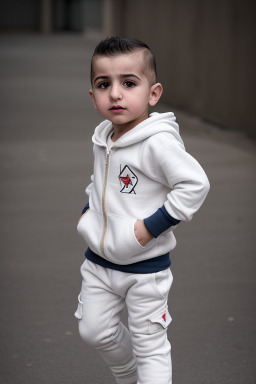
[0,35,256,384]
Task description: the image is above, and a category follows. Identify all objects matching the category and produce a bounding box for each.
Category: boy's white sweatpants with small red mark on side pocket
[75,260,173,384]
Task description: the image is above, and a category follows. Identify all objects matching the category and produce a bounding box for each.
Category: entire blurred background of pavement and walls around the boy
[0,0,256,384]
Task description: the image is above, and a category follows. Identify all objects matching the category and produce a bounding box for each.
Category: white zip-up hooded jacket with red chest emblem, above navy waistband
[77,112,209,265]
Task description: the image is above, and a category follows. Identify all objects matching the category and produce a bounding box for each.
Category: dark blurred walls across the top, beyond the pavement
[0,0,256,137]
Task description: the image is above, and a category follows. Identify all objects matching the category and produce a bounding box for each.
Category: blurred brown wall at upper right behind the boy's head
[104,0,256,136]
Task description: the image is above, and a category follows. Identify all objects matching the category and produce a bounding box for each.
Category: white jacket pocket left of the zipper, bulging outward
[77,209,103,255]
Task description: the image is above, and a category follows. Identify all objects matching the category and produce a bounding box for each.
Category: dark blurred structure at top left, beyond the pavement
[0,0,102,33]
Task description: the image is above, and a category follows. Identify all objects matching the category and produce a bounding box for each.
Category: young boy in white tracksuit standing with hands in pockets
[75,37,209,384]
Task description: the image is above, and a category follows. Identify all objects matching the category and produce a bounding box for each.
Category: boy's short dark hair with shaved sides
[90,36,157,83]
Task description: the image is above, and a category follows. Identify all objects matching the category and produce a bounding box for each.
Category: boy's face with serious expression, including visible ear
[89,51,162,132]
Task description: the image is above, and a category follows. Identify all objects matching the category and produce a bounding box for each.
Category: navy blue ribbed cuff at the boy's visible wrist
[144,205,180,237]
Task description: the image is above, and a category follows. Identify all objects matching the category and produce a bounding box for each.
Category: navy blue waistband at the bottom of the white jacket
[85,248,171,274]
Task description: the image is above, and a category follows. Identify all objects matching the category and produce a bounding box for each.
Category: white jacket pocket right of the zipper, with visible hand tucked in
[105,215,155,264]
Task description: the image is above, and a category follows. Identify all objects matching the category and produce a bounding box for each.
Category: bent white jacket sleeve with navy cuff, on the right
[144,142,210,237]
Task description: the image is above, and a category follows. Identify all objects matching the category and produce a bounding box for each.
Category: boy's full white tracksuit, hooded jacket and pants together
[76,113,209,384]
